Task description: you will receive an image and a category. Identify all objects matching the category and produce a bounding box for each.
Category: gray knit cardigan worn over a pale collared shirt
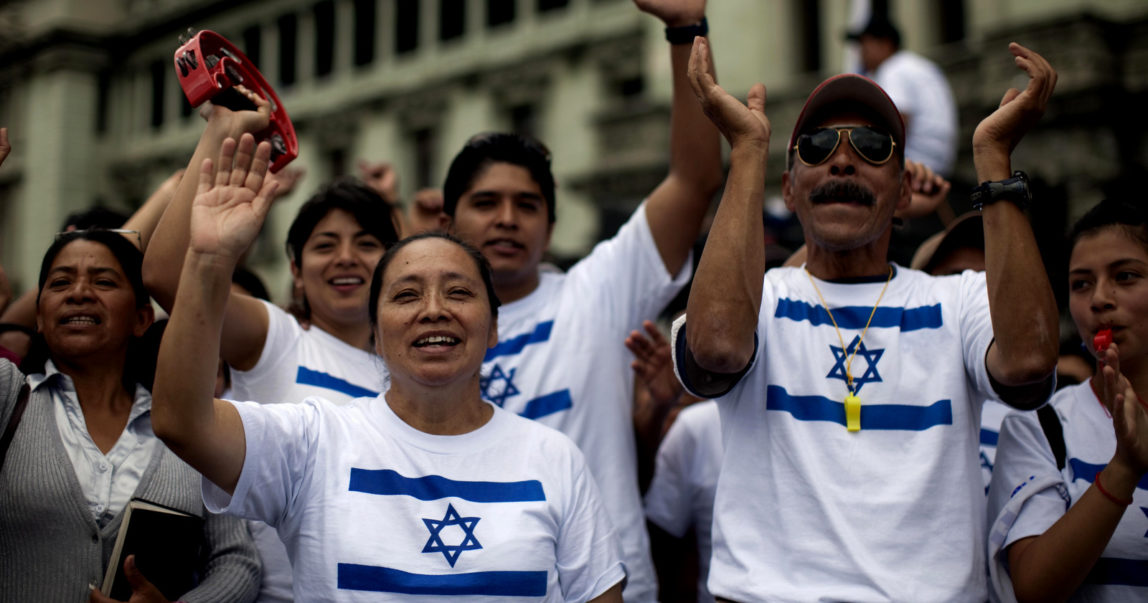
[0,360,261,603]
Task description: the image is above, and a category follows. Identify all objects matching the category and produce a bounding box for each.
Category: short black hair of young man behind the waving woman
[442,132,557,224]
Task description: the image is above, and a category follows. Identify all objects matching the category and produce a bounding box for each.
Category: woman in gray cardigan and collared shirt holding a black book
[0,230,259,602]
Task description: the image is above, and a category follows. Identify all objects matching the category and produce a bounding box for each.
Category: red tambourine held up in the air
[174,30,298,172]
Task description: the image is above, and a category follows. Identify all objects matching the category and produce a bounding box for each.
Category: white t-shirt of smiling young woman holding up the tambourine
[227,302,388,603]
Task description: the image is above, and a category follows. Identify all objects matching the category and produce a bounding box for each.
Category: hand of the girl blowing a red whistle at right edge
[1100,343,1148,476]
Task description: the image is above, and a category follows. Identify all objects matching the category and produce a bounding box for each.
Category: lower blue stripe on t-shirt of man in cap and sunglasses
[766,385,953,431]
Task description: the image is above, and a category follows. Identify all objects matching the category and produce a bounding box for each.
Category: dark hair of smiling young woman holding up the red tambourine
[287,178,398,317]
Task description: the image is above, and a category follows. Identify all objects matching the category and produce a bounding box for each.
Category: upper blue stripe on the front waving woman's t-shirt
[348,467,546,503]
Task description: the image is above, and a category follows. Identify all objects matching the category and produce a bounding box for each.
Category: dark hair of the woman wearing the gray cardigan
[20,229,158,391]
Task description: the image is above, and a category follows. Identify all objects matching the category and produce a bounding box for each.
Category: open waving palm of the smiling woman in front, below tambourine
[189,133,279,261]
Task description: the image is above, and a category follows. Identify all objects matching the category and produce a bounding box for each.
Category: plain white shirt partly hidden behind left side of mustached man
[645,400,722,603]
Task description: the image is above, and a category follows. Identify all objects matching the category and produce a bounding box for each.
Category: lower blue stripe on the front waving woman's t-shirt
[339,563,546,597]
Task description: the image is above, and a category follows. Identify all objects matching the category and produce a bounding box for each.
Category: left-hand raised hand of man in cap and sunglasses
[689,38,770,149]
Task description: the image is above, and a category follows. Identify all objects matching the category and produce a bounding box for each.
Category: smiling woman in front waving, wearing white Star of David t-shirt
[155,137,626,602]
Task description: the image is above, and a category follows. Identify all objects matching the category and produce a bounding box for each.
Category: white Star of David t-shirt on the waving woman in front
[203,396,625,602]
